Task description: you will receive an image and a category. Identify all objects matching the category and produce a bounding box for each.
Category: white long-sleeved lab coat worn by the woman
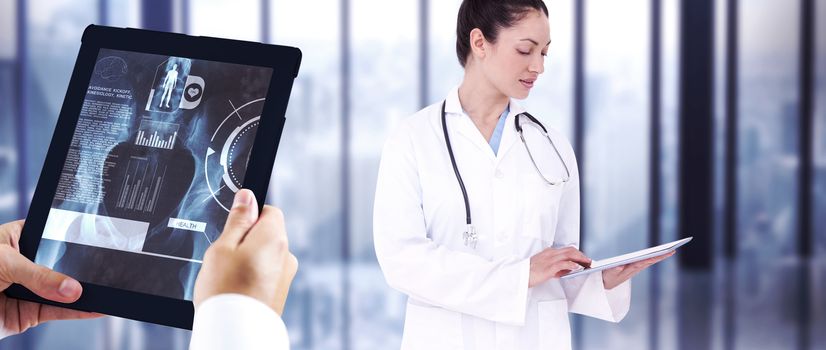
[373,89,631,350]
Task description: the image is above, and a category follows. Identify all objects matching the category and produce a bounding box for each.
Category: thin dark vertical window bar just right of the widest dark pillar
[723,0,740,349]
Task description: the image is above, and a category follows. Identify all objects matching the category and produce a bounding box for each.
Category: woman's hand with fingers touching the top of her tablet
[528,247,591,288]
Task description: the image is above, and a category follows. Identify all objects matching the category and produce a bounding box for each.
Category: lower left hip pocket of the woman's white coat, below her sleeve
[401,301,464,350]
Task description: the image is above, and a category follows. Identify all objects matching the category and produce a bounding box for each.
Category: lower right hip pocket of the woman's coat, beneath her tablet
[538,299,571,350]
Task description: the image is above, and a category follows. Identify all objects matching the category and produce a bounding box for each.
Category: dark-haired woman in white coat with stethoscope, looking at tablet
[373,0,667,350]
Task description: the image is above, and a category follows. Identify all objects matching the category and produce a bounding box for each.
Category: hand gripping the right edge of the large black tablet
[194,190,298,315]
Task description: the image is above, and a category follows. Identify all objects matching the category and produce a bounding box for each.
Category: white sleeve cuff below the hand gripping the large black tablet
[189,294,290,350]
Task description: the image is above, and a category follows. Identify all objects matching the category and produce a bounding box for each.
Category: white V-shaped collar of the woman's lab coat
[445,86,525,161]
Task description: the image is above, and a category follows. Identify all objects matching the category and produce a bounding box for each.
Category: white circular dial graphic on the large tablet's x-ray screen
[204,98,264,211]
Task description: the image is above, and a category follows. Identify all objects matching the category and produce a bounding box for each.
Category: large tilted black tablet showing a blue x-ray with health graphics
[6,25,301,329]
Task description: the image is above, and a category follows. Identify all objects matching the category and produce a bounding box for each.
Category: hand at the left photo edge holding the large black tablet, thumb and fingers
[0,220,103,338]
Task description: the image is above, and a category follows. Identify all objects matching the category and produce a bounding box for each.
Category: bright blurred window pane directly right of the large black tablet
[269,0,348,350]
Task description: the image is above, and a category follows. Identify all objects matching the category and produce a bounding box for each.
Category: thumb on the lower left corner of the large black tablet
[0,252,83,303]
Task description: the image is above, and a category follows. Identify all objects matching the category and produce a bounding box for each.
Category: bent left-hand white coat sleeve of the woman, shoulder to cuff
[373,124,530,325]
